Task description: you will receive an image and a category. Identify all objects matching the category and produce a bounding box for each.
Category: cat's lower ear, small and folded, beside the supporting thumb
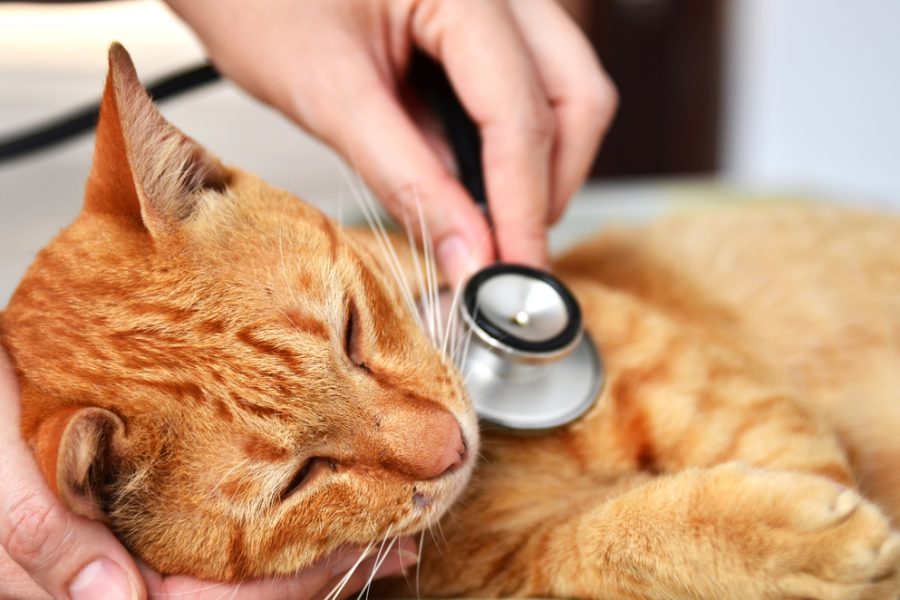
[37,407,126,520]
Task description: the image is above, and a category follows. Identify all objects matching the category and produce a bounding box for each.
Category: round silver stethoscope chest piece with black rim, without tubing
[460,264,603,432]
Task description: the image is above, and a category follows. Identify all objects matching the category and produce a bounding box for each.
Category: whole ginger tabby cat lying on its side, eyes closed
[2,45,900,600]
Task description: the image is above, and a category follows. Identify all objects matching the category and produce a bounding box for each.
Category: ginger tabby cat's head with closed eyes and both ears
[3,45,478,579]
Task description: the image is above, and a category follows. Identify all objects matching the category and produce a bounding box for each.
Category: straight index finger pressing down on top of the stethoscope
[412,0,555,267]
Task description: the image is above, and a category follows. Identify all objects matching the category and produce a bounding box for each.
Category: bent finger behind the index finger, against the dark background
[509,0,618,223]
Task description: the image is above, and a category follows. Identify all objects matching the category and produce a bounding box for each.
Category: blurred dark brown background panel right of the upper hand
[573,0,727,180]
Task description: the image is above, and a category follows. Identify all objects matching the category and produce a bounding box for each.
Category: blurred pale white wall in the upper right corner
[722,0,900,207]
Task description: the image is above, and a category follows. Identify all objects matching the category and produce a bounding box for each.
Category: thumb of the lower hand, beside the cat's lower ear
[0,350,145,600]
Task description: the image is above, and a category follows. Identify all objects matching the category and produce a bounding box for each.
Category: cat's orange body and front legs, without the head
[406,206,900,598]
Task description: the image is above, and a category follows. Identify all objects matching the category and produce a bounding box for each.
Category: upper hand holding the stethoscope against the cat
[167,0,616,281]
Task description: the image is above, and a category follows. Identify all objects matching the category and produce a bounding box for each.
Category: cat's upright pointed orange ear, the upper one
[84,43,229,237]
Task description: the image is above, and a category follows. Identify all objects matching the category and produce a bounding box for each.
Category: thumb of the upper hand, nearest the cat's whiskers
[308,50,494,284]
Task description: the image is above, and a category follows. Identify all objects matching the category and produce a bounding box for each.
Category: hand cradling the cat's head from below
[0,348,416,600]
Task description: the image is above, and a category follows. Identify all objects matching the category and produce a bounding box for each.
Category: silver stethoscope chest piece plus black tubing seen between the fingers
[410,52,603,432]
